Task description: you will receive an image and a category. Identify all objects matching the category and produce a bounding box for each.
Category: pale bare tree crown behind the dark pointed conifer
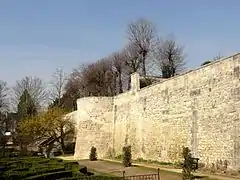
[13,76,48,109]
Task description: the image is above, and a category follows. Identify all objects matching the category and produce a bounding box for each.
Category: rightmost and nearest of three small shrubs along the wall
[182,147,194,180]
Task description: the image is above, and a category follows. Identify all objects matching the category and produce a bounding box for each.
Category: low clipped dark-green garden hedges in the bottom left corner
[0,157,122,180]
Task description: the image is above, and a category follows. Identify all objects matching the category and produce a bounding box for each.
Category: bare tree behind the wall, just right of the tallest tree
[156,39,185,78]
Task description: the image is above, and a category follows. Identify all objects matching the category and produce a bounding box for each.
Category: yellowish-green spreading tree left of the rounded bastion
[19,107,75,155]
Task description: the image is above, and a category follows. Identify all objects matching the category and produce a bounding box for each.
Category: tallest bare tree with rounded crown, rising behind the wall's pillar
[127,18,156,76]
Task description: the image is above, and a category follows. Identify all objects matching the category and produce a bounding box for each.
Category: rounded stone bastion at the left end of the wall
[74,97,113,159]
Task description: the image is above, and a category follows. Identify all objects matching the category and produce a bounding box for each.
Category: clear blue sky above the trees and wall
[0,0,240,86]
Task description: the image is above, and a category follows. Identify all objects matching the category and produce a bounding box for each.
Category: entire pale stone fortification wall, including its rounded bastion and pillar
[72,54,240,169]
